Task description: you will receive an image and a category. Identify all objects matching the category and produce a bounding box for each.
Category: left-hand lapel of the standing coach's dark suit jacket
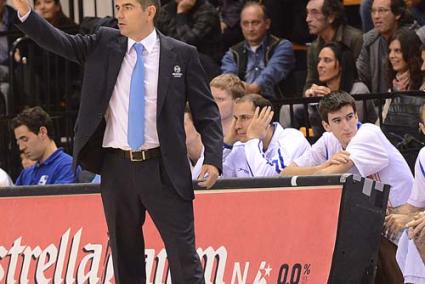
[106,36,127,102]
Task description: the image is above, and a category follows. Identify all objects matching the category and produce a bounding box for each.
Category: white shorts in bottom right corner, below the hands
[396,230,425,284]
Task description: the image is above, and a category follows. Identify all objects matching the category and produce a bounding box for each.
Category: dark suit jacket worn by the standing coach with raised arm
[18,12,223,199]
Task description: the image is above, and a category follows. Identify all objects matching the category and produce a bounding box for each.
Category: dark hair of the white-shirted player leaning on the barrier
[319,91,356,123]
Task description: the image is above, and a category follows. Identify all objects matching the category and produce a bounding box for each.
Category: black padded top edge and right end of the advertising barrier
[0,174,390,283]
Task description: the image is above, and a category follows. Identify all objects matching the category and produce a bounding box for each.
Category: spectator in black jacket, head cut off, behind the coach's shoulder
[156,0,223,79]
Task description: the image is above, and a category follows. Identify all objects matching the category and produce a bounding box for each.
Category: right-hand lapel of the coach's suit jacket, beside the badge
[156,31,176,117]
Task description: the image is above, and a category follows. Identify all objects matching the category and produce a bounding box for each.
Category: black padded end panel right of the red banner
[328,176,390,284]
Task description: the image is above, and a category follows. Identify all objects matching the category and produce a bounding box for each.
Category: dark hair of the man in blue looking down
[10,106,54,139]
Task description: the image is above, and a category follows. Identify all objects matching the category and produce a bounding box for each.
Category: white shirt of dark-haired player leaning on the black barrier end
[295,123,413,207]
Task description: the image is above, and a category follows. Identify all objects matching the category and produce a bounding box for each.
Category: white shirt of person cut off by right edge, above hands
[407,147,425,208]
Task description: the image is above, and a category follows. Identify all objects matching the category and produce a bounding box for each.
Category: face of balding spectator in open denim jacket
[241,5,270,45]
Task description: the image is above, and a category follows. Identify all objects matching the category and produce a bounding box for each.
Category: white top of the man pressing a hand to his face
[223,123,310,177]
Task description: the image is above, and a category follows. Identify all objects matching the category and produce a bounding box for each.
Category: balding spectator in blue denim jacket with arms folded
[221,1,295,100]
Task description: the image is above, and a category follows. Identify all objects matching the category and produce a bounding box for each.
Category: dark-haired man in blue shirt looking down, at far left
[11,107,79,185]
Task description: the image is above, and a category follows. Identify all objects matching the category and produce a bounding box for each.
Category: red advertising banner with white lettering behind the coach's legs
[0,186,342,284]
